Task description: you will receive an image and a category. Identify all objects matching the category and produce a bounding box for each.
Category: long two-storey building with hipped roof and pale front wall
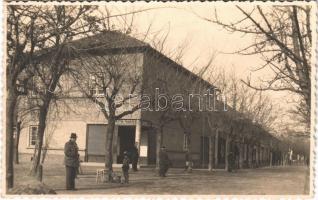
[19,31,288,169]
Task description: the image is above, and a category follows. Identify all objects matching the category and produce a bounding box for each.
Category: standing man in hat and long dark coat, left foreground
[64,133,79,190]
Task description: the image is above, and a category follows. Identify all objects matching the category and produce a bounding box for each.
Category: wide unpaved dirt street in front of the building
[16,157,309,195]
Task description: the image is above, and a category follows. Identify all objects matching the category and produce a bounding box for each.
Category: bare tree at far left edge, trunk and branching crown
[6,6,40,189]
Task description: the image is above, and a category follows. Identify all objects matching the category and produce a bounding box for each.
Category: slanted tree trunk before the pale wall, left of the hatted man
[30,101,49,176]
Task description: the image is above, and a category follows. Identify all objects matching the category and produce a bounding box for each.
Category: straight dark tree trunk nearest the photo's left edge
[6,87,17,190]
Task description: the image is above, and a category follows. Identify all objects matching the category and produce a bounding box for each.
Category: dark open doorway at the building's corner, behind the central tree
[117,126,136,164]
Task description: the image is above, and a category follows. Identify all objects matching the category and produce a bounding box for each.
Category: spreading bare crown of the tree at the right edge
[200,5,312,131]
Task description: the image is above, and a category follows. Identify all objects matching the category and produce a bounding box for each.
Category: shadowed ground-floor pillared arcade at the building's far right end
[208,130,288,170]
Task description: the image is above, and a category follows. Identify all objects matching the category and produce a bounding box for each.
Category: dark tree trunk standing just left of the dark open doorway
[105,115,116,181]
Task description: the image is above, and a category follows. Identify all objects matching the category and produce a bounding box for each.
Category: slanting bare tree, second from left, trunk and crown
[24,6,100,175]
